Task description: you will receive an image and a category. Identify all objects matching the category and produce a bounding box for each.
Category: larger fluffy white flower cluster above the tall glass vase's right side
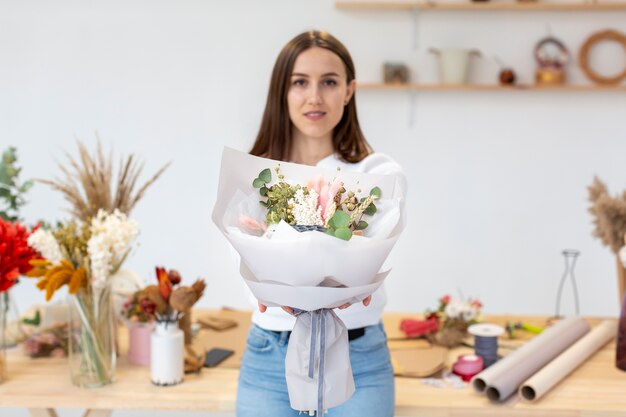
[87,209,139,286]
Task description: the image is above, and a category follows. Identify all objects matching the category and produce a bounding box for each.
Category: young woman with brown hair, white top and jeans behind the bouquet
[237,31,406,417]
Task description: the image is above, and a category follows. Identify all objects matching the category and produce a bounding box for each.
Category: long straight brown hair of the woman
[250,31,372,162]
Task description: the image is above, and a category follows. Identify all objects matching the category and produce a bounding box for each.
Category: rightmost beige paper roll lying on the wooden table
[521,320,617,401]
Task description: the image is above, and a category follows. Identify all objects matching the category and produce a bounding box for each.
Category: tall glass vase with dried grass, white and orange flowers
[29,142,166,387]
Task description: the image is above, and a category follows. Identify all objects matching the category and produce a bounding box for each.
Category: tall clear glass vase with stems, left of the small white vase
[69,285,116,388]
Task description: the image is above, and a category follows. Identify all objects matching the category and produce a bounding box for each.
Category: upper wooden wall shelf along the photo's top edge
[335,0,626,11]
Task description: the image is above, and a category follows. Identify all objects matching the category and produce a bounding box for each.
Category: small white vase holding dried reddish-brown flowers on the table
[150,321,185,386]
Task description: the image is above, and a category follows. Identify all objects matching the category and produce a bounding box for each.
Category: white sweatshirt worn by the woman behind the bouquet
[250,153,407,331]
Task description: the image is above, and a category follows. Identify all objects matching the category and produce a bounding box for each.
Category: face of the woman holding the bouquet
[287,47,355,139]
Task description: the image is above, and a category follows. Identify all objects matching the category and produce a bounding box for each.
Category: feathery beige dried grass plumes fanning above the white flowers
[37,135,170,222]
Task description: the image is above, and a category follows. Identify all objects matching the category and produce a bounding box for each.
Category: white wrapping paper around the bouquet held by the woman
[212,148,405,410]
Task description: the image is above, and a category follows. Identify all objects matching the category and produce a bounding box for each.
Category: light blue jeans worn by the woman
[236,323,394,417]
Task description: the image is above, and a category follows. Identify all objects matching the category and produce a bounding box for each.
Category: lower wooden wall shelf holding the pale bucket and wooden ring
[357,83,626,91]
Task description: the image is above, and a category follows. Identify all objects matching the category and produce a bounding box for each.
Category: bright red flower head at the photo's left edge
[0,218,38,292]
